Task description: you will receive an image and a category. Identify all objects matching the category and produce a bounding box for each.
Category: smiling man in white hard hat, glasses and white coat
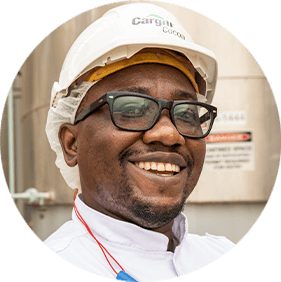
[44,4,234,281]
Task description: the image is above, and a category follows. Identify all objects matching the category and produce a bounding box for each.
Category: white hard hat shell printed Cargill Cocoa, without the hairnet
[51,3,217,107]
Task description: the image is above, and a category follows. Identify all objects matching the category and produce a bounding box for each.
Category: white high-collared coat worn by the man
[44,194,235,282]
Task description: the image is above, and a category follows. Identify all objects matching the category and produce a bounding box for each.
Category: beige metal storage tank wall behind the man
[0,1,281,243]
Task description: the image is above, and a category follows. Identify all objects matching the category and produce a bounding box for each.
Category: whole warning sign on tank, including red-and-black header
[204,132,255,171]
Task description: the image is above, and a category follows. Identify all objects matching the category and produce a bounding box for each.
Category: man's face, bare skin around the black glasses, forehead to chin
[67,64,203,229]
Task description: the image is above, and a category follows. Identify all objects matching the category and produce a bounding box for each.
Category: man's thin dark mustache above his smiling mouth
[119,145,194,174]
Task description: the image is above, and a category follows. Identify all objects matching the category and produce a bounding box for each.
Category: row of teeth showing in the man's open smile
[134,162,181,177]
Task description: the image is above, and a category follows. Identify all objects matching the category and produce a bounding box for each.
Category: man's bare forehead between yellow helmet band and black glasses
[79,64,197,108]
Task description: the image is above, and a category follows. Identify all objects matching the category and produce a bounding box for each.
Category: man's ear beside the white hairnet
[58,123,78,167]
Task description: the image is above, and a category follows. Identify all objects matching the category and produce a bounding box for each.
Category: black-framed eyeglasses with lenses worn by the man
[74,92,217,139]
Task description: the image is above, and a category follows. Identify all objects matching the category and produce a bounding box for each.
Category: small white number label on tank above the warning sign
[214,111,247,125]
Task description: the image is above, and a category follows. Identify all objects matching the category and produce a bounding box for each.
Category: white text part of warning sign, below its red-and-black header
[204,141,255,171]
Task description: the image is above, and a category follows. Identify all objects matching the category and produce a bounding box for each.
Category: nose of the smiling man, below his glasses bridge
[143,109,185,146]
